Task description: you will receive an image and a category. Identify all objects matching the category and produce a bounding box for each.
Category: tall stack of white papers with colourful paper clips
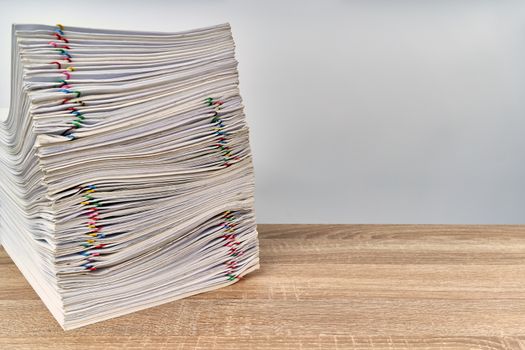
[0,24,259,329]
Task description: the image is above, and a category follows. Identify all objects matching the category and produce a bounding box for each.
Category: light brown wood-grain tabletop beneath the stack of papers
[0,225,525,350]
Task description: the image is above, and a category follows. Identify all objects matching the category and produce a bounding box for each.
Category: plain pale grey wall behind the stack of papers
[0,0,525,223]
